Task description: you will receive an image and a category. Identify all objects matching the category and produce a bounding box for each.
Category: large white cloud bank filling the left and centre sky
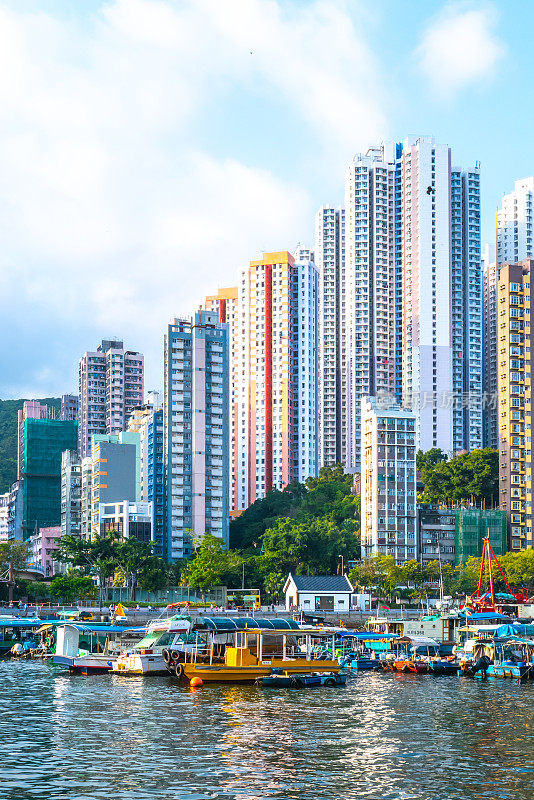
[0,0,385,396]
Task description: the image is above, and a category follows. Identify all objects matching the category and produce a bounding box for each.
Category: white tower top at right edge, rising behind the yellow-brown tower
[497,176,534,266]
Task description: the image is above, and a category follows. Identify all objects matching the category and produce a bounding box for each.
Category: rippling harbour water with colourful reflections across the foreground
[0,661,534,800]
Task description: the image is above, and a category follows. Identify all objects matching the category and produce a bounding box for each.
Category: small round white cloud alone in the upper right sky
[416,3,505,97]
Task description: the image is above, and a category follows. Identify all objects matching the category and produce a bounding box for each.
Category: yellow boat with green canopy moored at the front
[168,618,340,683]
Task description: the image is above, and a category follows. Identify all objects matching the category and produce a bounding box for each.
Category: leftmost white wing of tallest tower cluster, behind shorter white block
[341,144,397,472]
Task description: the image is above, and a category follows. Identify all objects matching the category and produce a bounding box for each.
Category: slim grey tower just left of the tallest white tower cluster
[315,206,347,466]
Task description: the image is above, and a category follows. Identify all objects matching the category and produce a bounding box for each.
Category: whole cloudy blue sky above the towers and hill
[0,0,534,399]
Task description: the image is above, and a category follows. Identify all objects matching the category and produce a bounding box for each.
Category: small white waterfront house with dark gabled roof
[284,573,354,613]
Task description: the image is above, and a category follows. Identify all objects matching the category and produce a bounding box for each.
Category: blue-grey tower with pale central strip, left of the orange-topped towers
[163,311,230,560]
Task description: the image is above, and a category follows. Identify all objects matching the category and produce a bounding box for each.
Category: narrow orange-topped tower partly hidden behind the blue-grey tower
[205,286,243,516]
